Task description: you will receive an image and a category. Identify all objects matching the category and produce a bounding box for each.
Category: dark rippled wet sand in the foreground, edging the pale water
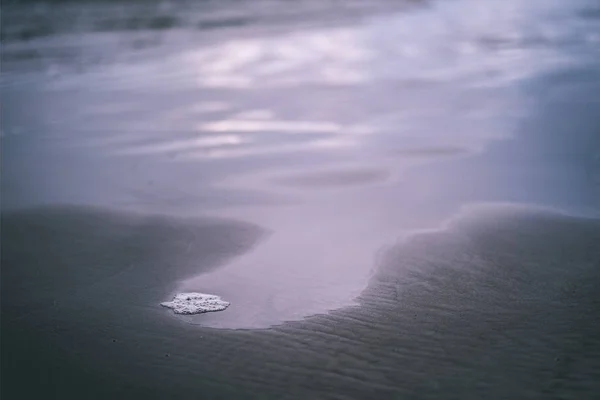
[1,206,600,399]
